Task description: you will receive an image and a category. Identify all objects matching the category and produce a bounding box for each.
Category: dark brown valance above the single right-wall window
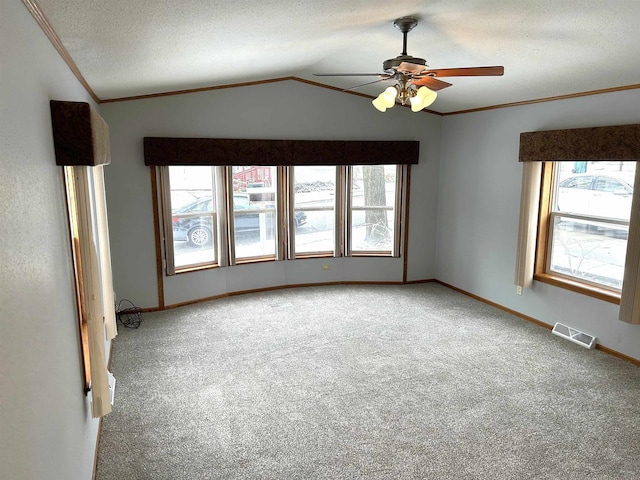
[520,125,640,162]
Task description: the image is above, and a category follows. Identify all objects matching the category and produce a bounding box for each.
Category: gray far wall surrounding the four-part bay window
[100,81,442,307]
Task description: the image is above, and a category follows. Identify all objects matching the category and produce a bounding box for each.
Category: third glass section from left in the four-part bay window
[292,166,336,255]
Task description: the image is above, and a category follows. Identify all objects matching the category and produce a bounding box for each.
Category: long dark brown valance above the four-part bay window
[144,137,420,166]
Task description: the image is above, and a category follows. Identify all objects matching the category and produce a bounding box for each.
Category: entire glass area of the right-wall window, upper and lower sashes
[548,161,636,289]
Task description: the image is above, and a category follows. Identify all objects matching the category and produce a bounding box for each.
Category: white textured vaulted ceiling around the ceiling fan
[35,0,640,113]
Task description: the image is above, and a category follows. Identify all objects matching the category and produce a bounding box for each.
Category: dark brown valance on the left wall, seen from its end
[49,100,111,167]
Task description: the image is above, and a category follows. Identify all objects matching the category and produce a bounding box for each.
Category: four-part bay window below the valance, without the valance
[158,165,406,275]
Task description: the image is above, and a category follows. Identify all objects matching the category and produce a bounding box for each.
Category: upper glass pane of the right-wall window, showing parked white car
[554,161,636,221]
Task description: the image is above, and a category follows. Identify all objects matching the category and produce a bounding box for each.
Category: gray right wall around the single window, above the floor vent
[436,90,640,358]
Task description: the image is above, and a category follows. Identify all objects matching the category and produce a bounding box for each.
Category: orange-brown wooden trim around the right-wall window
[533,161,621,304]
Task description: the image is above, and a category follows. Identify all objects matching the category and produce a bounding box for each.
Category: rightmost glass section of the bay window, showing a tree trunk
[351,165,397,254]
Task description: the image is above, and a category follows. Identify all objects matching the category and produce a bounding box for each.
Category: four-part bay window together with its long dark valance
[144,137,419,275]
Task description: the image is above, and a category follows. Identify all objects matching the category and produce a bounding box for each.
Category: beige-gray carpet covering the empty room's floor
[97,284,640,480]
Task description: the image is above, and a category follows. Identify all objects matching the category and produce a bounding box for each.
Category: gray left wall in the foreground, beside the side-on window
[0,1,98,480]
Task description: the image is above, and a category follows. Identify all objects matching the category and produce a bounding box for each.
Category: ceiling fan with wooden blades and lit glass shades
[314,17,504,112]
